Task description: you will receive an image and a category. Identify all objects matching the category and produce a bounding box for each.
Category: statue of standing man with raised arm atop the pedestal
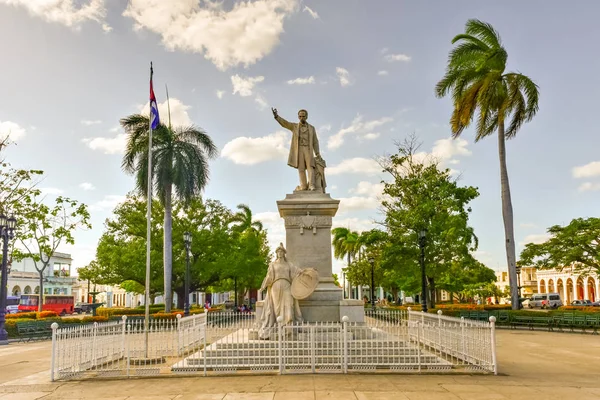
[271,108,321,190]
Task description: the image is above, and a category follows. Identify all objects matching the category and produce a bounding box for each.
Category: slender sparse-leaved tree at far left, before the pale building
[13,196,92,312]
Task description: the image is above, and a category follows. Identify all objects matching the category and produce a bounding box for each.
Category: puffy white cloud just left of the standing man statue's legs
[221,131,291,165]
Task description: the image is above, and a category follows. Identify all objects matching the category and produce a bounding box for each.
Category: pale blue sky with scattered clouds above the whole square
[0,0,600,276]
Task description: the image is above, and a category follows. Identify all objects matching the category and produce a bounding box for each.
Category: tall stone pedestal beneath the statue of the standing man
[277,191,364,322]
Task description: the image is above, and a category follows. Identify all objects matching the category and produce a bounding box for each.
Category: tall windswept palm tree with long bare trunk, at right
[435,19,539,309]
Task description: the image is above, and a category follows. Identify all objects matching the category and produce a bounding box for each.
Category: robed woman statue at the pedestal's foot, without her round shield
[258,243,302,339]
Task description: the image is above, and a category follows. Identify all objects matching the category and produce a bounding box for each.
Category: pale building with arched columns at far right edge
[537,266,600,305]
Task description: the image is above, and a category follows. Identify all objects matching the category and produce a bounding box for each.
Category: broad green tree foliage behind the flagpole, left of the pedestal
[88,194,269,306]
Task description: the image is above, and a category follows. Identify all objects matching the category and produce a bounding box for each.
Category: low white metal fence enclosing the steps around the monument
[51,310,497,380]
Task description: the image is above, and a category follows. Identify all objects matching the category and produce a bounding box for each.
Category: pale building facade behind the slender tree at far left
[8,252,77,296]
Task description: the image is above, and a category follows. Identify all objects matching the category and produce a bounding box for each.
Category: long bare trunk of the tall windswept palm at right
[498,121,519,310]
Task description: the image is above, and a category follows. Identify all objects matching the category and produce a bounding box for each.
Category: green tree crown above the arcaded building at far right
[519,218,600,274]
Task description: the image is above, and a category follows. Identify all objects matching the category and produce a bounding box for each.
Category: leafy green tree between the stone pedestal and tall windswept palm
[382,137,479,306]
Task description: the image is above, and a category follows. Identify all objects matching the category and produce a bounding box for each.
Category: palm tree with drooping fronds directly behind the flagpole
[121,114,218,312]
